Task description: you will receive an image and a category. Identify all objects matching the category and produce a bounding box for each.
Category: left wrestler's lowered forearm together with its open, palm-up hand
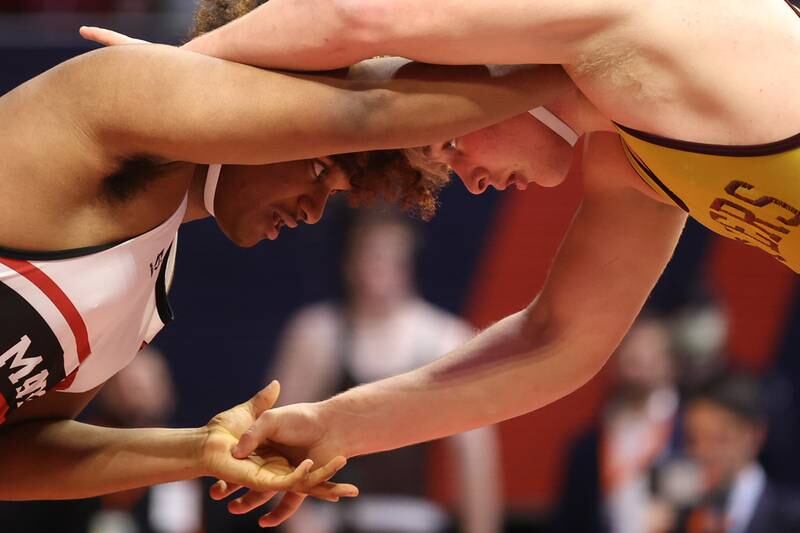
[0,382,354,500]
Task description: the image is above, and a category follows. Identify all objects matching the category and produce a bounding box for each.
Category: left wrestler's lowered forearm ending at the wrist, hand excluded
[0,420,205,500]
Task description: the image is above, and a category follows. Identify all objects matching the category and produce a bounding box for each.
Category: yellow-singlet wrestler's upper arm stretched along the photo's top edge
[180,0,633,70]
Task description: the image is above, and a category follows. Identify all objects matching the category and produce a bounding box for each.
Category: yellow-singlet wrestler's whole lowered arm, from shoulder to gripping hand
[234,135,686,457]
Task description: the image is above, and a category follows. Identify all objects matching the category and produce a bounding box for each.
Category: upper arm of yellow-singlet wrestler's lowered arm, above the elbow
[532,134,686,350]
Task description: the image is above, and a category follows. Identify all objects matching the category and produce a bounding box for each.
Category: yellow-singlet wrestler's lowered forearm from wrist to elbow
[320,310,618,456]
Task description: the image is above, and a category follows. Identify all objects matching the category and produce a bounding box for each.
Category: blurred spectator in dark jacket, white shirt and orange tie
[552,317,679,533]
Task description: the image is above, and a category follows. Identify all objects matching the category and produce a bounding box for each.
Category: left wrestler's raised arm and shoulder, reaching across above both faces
[20,45,569,172]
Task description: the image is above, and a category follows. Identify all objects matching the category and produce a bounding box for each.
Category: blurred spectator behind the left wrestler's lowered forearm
[0,347,203,533]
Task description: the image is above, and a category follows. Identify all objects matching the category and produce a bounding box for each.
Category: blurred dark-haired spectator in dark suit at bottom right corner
[675,375,800,533]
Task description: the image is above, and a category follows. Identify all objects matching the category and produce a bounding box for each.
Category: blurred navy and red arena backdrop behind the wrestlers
[0,1,800,524]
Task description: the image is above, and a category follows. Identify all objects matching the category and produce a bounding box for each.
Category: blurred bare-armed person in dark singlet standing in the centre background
[274,210,501,533]
